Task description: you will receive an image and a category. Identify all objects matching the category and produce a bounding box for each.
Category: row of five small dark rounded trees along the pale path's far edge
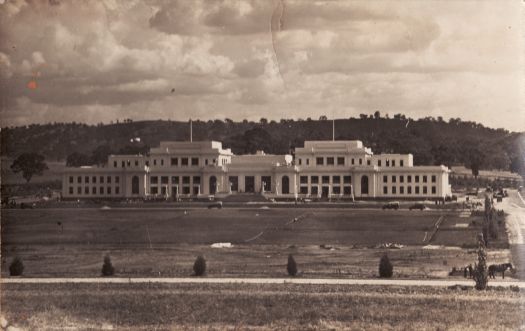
[9,253,394,278]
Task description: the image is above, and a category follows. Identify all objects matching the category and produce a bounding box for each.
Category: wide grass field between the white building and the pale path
[1,208,509,278]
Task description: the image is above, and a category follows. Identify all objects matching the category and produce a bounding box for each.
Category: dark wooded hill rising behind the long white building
[1,113,525,176]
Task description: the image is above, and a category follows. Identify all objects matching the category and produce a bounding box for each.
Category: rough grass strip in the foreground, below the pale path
[1,284,525,330]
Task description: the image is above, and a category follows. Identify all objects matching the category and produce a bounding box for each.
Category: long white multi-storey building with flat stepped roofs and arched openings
[62,140,451,199]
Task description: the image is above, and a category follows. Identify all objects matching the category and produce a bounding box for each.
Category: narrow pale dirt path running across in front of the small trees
[4,277,525,289]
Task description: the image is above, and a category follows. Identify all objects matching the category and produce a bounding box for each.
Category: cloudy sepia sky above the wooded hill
[0,0,525,131]
